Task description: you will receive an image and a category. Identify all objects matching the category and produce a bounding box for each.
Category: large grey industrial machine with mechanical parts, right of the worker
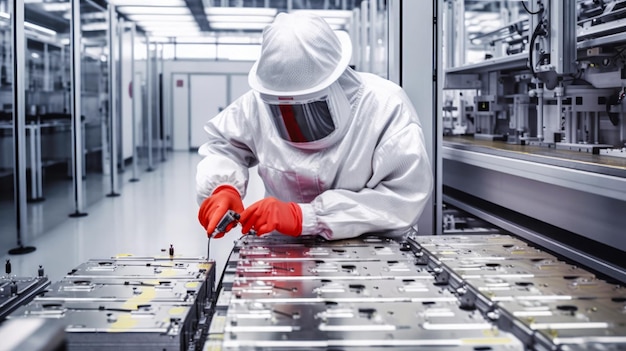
[442,0,626,279]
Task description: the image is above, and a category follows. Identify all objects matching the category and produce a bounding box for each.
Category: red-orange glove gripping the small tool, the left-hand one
[198,185,243,238]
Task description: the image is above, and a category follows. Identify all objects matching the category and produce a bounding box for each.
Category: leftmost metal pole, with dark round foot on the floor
[9,0,36,255]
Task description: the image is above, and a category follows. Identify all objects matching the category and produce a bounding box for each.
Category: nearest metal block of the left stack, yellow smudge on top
[11,300,196,350]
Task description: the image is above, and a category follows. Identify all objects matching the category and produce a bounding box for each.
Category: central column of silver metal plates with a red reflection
[211,236,523,350]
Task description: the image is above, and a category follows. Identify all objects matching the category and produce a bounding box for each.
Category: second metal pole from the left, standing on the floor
[70,0,87,217]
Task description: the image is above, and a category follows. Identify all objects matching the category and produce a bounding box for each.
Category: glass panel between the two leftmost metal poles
[24,3,72,237]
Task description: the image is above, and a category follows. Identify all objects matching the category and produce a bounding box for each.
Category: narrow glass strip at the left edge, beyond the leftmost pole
[0,0,17,254]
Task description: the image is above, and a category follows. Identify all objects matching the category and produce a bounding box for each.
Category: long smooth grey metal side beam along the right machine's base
[443,146,626,281]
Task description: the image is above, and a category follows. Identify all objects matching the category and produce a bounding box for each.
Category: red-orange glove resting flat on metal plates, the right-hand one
[239,197,302,236]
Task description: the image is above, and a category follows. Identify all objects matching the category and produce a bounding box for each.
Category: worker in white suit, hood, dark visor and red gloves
[196,13,432,240]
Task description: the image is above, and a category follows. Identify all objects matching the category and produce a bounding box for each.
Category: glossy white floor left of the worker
[2,152,264,282]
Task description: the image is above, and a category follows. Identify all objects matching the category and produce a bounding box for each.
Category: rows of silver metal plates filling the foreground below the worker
[4,233,626,351]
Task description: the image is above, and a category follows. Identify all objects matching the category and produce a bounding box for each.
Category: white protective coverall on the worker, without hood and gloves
[196,15,433,240]
